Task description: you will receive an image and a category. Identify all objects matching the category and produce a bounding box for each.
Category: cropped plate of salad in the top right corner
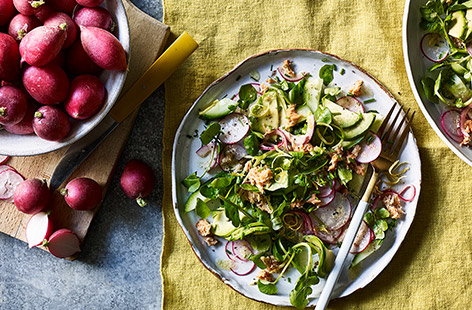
[403,0,472,166]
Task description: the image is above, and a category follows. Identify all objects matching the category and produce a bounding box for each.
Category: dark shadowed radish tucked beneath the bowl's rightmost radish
[66,39,103,75]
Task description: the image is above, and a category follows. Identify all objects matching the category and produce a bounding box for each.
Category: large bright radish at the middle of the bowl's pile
[23,65,69,105]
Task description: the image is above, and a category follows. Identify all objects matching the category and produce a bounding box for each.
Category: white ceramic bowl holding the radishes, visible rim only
[0,0,130,156]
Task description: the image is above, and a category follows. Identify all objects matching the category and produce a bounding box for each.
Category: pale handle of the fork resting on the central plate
[315,170,379,310]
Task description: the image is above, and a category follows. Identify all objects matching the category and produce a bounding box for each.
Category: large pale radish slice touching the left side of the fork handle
[313,194,351,231]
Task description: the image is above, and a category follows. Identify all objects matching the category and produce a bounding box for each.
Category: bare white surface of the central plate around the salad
[172,50,421,306]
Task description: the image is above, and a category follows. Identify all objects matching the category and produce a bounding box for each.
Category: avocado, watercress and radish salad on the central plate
[182,60,416,308]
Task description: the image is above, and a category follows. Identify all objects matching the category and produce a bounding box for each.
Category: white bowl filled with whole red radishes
[0,0,130,156]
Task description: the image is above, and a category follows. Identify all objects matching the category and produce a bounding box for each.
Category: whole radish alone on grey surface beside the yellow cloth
[120,159,156,207]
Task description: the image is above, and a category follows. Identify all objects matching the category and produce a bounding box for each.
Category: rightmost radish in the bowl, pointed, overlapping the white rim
[80,27,128,71]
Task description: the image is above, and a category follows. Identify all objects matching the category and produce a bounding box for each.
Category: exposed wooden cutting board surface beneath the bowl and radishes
[0,0,169,252]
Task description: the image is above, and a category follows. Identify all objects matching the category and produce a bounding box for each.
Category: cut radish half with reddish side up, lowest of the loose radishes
[43,228,80,258]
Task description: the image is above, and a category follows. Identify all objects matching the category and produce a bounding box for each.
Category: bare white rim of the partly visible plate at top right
[403,0,472,166]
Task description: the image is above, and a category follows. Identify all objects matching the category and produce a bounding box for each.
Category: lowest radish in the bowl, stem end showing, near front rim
[33,106,71,141]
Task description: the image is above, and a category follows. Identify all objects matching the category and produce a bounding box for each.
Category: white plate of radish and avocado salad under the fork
[172,50,421,308]
